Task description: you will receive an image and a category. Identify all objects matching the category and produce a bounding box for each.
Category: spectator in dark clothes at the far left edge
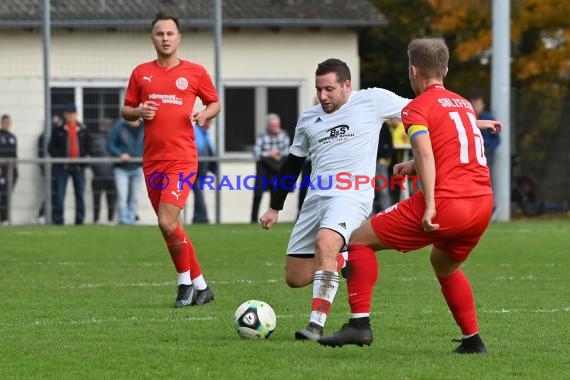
[0,115,18,225]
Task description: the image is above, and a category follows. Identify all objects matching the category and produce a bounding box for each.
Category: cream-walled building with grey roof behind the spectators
[0,0,385,224]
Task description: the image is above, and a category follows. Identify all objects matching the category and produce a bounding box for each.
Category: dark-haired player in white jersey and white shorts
[260,59,409,340]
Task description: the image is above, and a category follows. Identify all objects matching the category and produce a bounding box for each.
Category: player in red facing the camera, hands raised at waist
[122,12,220,307]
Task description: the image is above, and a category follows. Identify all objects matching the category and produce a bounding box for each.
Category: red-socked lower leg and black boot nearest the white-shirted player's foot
[318,244,378,347]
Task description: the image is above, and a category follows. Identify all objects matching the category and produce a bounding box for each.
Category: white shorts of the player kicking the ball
[287,196,372,257]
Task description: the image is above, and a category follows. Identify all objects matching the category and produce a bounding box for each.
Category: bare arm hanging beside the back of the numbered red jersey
[411,133,439,232]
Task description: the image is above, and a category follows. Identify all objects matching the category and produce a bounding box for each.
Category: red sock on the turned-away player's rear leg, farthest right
[437,269,479,335]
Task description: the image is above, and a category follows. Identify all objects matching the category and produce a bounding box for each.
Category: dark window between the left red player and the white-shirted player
[223,85,300,153]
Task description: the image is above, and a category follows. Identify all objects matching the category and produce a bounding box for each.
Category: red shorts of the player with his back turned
[370,191,493,262]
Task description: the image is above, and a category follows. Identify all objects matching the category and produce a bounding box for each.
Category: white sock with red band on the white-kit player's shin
[309,270,338,327]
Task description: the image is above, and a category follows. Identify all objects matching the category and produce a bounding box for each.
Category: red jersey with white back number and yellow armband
[402,84,493,198]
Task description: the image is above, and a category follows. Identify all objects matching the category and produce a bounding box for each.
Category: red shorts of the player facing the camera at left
[143,161,198,213]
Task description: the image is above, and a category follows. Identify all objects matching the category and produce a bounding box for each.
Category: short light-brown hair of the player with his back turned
[408,37,449,79]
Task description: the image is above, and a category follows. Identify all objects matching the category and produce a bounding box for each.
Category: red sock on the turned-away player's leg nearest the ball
[346,244,378,314]
